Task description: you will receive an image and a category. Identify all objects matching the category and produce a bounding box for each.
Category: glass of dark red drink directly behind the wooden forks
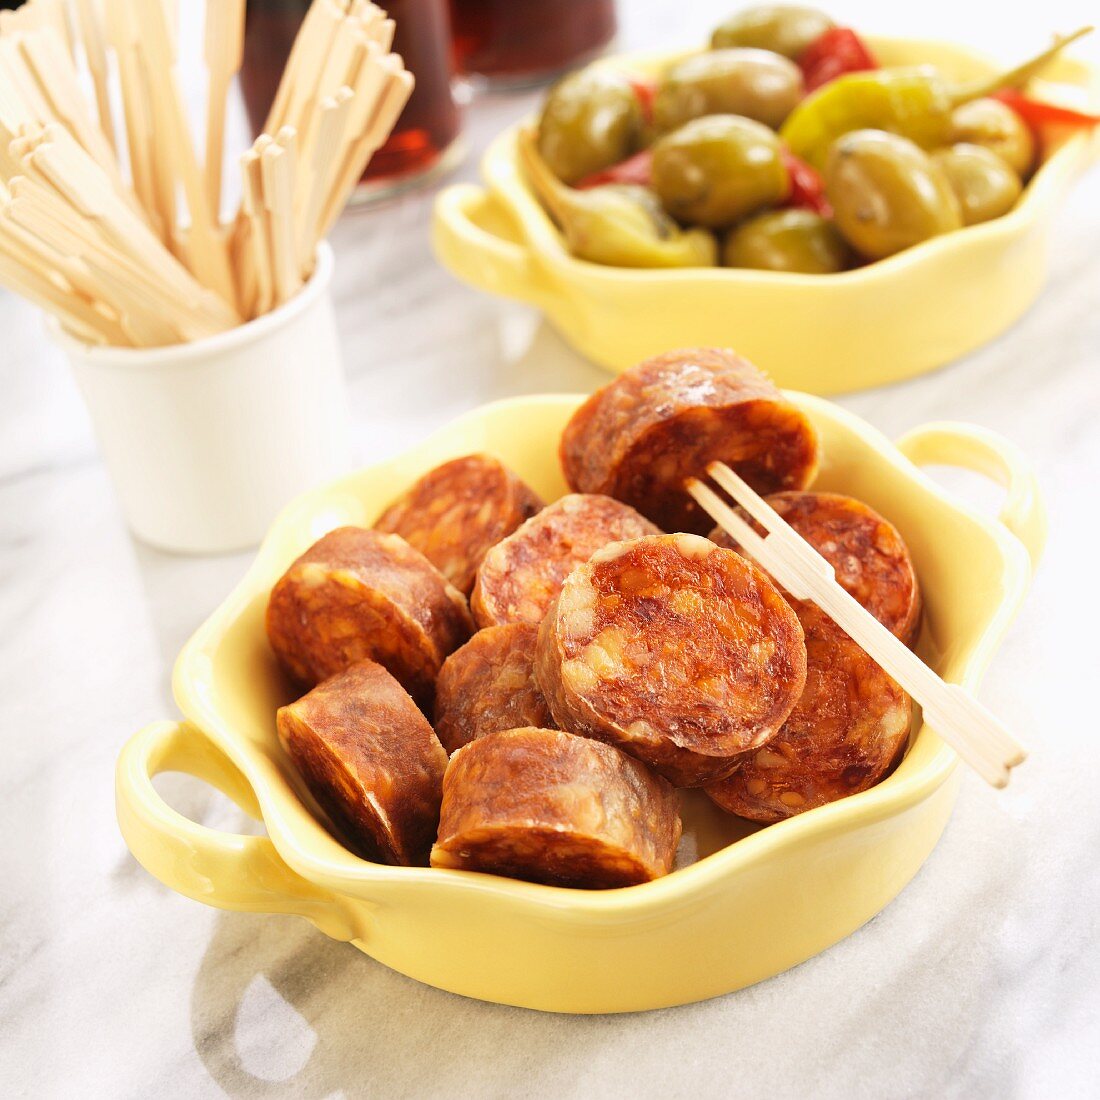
[241,0,461,183]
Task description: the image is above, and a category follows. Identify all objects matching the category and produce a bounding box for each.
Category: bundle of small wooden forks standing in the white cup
[0,0,413,347]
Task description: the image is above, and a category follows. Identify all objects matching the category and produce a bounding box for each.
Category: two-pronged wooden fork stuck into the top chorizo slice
[686,462,1026,788]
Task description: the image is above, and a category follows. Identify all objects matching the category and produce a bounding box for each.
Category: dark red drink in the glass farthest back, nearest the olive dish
[451,0,616,83]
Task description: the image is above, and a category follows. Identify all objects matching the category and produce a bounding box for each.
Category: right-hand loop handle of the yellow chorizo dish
[898,420,1047,570]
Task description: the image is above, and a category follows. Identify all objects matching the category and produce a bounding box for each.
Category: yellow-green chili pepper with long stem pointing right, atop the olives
[780,26,1092,171]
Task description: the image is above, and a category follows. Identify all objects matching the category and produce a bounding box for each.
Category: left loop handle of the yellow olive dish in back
[431,184,548,305]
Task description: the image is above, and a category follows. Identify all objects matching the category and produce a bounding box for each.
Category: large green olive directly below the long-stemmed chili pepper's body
[825,130,963,260]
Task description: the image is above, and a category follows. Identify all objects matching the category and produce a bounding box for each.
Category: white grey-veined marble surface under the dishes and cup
[0,0,1100,1098]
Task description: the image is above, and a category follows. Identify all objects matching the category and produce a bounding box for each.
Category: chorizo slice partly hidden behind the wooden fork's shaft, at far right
[711,492,921,646]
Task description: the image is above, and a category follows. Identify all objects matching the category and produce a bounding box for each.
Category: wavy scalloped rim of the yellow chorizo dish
[173,392,1031,923]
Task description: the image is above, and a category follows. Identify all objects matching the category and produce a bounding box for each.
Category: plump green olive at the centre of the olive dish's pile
[652,114,791,229]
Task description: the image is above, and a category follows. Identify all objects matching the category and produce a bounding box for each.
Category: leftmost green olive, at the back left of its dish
[538,68,642,184]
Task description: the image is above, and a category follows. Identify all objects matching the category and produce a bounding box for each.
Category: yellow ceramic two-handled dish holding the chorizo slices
[117,394,1044,1012]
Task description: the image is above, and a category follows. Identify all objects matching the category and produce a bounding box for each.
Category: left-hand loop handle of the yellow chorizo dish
[114,722,366,939]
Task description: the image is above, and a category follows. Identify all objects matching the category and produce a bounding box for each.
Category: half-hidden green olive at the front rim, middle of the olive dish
[722,210,850,275]
